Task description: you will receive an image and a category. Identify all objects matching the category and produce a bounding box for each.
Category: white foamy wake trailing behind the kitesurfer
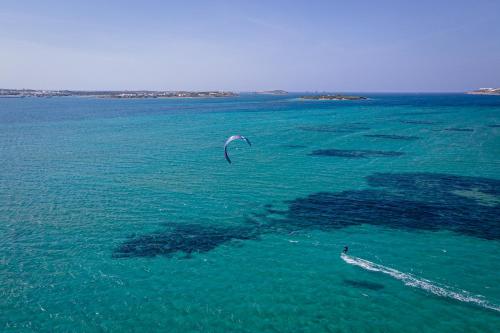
[340,253,500,312]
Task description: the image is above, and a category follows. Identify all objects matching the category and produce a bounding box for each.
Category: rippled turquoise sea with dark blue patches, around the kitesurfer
[0,94,500,332]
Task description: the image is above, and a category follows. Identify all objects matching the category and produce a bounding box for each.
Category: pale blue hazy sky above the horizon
[0,0,500,92]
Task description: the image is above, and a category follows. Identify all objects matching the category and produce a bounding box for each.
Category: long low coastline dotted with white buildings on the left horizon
[0,89,238,98]
